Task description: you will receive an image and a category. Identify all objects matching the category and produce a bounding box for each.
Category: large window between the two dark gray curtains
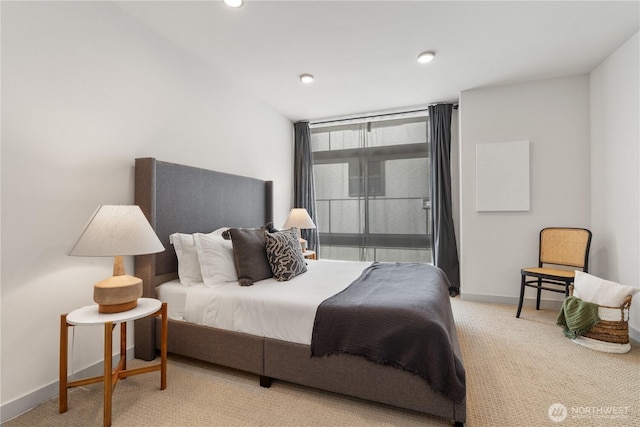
[311,117,432,262]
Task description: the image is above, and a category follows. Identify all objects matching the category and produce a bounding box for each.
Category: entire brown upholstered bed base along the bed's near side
[156,320,466,423]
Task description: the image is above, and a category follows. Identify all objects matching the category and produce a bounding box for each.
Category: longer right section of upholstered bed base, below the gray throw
[264,338,466,422]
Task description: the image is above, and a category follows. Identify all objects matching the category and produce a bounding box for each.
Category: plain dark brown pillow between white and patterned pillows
[229,228,273,286]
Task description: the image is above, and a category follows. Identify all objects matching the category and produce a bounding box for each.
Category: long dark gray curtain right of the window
[429,104,460,296]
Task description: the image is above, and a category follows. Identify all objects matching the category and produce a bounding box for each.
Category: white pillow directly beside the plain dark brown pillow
[193,230,238,285]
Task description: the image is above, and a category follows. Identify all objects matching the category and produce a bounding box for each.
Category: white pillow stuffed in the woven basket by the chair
[573,270,640,307]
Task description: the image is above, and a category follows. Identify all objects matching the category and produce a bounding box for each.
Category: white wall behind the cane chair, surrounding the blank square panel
[459,75,590,304]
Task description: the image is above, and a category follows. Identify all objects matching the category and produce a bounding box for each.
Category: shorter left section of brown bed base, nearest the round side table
[155,319,263,375]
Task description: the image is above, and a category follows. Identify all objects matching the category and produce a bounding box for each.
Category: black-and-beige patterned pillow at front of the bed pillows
[265,228,307,282]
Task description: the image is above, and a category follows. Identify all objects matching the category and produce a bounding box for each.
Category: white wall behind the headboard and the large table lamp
[0,2,293,420]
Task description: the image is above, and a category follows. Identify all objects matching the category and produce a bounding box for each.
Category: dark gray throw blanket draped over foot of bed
[311,263,465,403]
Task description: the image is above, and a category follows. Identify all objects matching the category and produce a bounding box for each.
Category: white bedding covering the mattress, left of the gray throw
[159,260,370,345]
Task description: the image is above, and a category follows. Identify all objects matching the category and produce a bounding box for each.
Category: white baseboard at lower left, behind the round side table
[0,347,134,423]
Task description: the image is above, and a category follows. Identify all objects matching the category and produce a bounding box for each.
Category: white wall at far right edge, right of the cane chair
[590,33,640,338]
